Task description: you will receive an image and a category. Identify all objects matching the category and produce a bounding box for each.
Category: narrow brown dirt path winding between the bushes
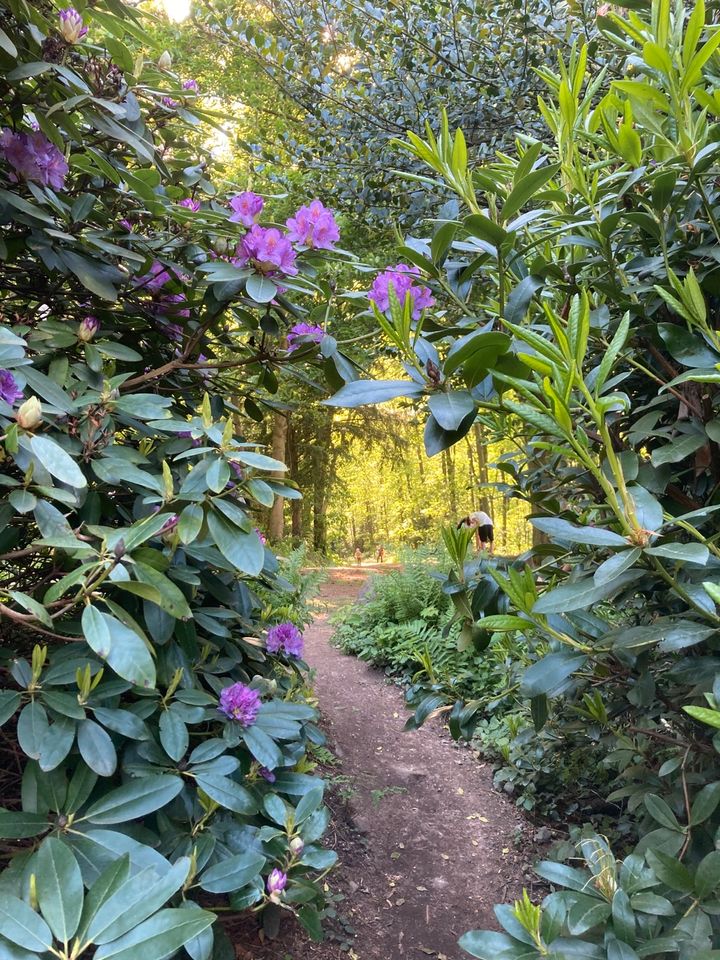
[235,564,528,960]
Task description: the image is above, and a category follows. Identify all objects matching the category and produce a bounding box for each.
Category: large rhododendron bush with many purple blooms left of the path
[0,0,348,960]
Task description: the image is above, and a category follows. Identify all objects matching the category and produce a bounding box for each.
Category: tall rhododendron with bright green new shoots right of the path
[333,0,720,960]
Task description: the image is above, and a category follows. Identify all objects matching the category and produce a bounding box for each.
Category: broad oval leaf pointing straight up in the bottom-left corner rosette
[35,837,85,943]
